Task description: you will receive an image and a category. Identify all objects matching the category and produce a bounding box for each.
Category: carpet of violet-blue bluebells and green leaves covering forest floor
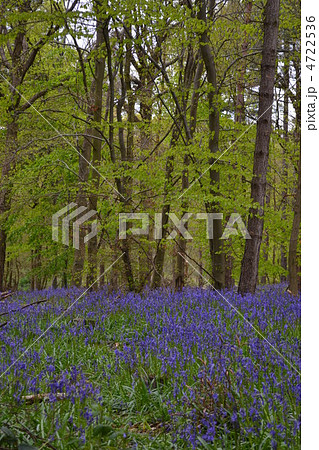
[0,285,300,450]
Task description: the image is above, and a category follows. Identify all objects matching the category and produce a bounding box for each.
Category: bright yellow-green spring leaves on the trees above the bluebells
[0,0,300,287]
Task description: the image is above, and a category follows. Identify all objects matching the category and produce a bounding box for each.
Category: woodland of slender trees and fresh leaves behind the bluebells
[0,0,301,293]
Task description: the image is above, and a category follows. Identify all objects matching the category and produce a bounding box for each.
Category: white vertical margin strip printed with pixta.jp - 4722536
[301,0,319,450]
